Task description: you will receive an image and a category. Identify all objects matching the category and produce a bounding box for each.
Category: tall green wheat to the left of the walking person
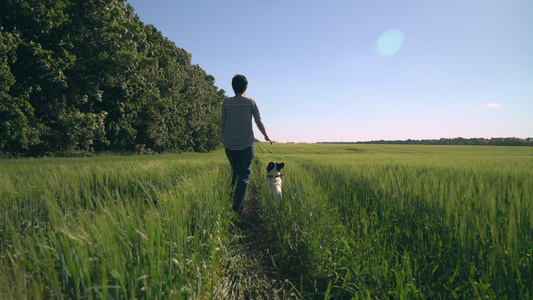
[0,155,233,299]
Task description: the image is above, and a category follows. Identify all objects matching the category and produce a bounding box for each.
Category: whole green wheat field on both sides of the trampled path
[0,143,533,299]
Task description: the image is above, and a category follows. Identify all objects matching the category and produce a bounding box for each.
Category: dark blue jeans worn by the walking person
[226,146,254,213]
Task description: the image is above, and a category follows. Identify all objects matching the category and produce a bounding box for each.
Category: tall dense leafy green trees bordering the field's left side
[0,0,225,156]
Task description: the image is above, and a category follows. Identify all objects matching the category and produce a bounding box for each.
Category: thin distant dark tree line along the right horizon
[324,137,533,146]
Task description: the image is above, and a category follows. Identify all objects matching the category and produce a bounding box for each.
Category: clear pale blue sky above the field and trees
[128,0,533,142]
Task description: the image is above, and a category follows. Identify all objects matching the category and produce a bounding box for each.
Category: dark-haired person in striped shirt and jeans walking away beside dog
[220,74,272,214]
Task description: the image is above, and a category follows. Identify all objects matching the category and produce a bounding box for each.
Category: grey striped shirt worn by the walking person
[220,97,265,150]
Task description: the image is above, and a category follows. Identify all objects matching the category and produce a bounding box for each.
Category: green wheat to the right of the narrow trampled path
[254,145,533,299]
